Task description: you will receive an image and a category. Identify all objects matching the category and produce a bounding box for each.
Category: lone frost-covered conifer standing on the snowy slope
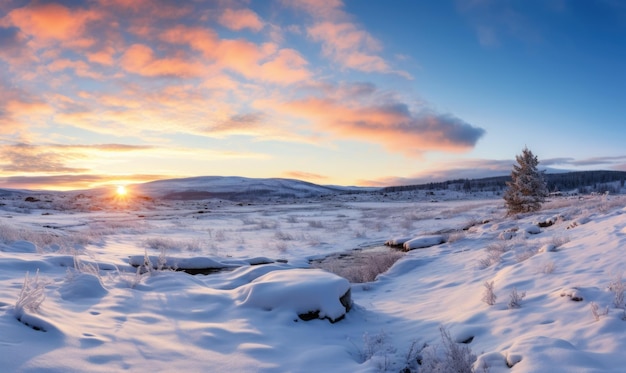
[504,147,548,214]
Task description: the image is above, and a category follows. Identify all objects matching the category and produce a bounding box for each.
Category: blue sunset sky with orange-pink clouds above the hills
[0,0,626,190]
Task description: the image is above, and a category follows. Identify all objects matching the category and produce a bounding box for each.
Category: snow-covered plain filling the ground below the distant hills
[0,185,626,372]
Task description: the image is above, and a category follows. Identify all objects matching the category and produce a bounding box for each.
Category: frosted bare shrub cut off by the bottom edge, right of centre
[420,327,476,373]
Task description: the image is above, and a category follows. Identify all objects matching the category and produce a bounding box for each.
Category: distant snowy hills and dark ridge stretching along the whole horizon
[0,171,626,201]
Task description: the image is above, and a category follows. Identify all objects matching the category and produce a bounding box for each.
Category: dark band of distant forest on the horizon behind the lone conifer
[383,171,626,194]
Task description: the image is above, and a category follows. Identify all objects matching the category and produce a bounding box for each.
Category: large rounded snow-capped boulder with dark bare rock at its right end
[238,269,352,323]
